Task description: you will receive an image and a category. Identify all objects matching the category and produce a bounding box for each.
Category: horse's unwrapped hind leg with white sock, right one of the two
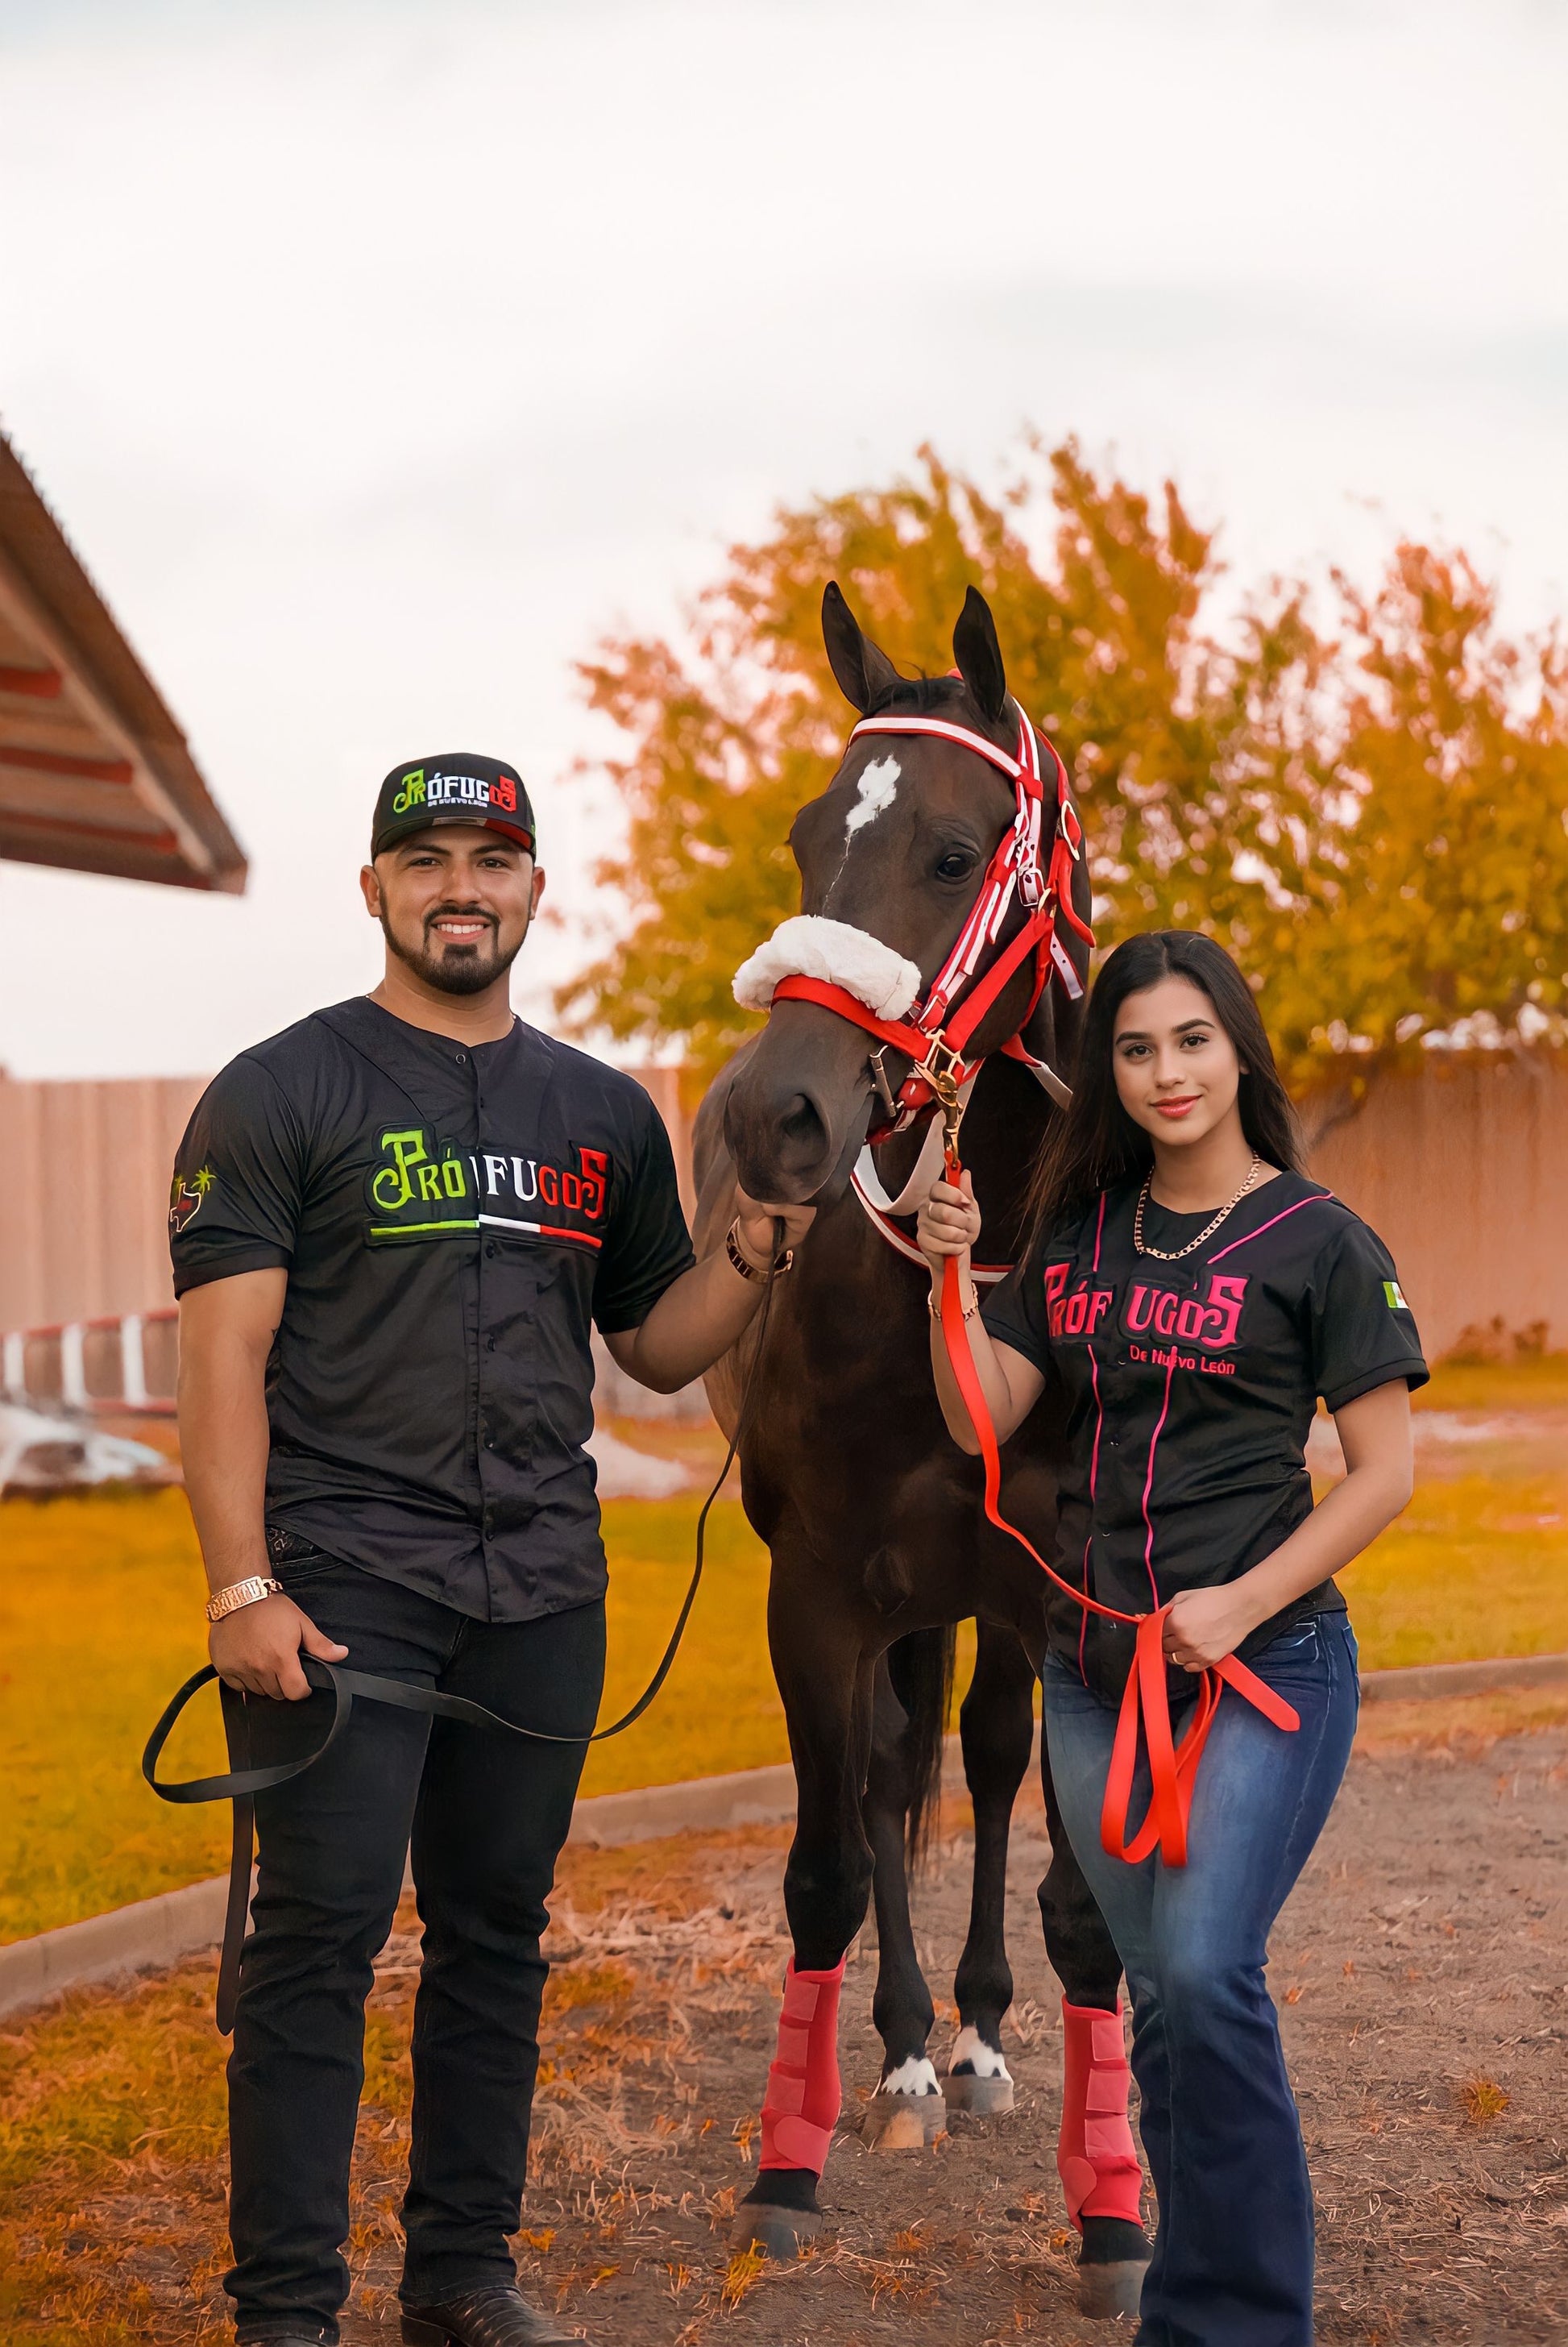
[944,1622,1035,2112]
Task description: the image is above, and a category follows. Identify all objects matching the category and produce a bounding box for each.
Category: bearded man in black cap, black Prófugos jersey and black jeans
[169,756,810,2347]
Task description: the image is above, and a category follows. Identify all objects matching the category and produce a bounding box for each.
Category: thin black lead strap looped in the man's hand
[141,1223,784,2038]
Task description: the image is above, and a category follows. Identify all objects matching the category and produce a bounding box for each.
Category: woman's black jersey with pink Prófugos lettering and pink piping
[984,1174,1427,1697]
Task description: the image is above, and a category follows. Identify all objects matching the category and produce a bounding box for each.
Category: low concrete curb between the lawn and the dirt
[0,1655,1568,2021]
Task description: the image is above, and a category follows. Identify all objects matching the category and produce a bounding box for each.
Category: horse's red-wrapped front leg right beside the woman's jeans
[1040,1737,1152,2319]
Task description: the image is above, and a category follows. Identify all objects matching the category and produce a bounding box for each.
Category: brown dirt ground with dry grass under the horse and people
[0,1706,1568,2347]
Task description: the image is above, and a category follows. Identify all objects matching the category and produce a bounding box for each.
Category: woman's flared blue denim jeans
[1044,1613,1359,2347]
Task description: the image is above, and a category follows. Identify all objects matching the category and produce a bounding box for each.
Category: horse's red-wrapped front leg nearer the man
[730,1576,876,2258]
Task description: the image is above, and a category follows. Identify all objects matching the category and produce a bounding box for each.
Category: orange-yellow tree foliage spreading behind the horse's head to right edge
[558,441,1568,1084]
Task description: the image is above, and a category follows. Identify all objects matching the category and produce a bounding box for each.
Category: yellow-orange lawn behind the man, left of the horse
[0,1490,789,1941]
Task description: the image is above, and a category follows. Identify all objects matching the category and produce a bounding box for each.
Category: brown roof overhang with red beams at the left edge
[0,432,247,894]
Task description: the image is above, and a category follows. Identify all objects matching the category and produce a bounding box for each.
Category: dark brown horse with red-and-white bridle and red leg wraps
[695,584,1150,2316]
